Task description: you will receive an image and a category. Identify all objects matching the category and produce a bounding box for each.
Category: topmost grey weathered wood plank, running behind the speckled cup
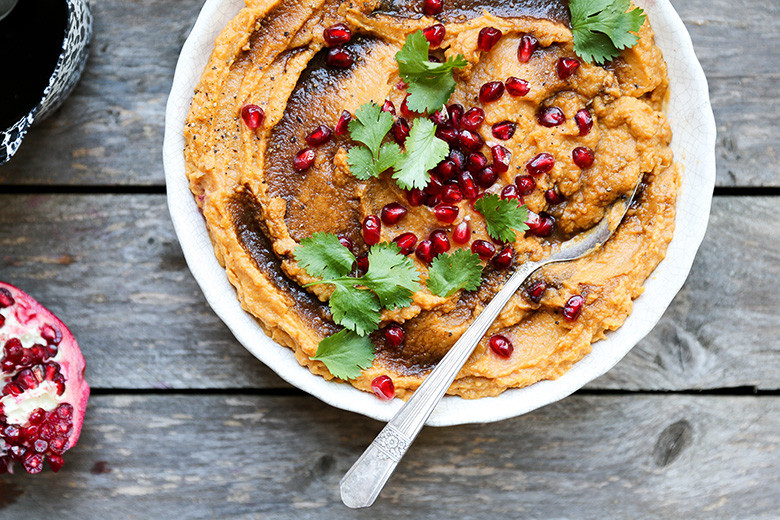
[0,0,780,186]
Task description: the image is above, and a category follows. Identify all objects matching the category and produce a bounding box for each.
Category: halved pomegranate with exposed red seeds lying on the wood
[0,282,89,473]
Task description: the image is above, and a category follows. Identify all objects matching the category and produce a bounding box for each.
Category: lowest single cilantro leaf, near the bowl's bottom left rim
[311,330,374,380]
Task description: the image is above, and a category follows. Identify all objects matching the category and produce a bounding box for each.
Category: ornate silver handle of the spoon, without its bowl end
[339,260,550,508]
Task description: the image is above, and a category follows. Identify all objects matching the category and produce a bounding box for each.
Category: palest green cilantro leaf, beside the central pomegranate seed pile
[393,117,450,190]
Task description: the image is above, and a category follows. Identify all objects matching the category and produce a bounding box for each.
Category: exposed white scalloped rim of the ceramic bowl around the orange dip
[163,0,715,426]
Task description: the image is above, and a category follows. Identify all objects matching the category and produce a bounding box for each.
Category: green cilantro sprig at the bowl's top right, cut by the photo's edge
[569,0,645,64]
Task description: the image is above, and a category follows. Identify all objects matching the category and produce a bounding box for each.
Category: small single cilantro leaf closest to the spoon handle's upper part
[426,249,482,298]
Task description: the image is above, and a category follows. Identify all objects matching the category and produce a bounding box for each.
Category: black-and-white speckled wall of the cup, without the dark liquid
[0,0,92,165]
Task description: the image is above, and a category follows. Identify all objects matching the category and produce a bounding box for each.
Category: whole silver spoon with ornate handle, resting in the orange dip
[339,182,640,508]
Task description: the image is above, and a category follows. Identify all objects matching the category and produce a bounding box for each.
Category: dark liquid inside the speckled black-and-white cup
[0,0,68,130]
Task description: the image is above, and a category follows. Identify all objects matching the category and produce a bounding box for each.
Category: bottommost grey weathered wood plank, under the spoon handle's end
[0,395,780,520]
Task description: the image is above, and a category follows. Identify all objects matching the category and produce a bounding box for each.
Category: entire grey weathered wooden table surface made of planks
[0,0,780,520]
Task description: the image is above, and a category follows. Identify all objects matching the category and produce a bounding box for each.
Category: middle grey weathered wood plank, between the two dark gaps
[0,195,780,390]
